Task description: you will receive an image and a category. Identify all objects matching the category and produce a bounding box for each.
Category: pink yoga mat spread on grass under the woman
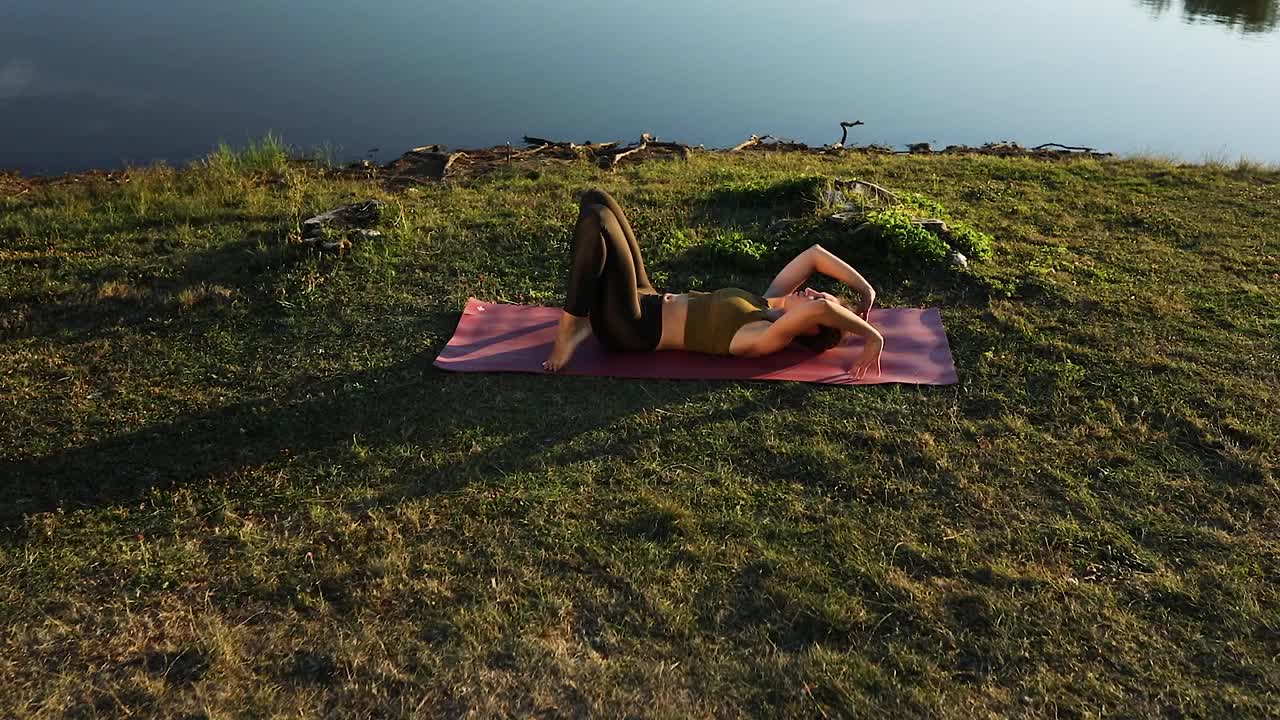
[435,297,957,386]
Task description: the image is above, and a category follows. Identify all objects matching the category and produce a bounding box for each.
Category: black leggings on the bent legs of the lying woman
[564,190,662,351]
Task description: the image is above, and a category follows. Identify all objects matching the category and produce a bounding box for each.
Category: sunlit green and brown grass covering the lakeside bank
[0,142,1280,720]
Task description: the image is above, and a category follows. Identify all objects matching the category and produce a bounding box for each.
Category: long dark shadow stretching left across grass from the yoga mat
[0,338,806,527]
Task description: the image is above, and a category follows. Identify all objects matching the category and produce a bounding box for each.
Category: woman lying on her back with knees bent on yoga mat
[543,190,884,379]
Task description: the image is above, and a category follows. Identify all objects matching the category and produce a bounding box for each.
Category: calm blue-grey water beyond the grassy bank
[0,0,1280,173]
